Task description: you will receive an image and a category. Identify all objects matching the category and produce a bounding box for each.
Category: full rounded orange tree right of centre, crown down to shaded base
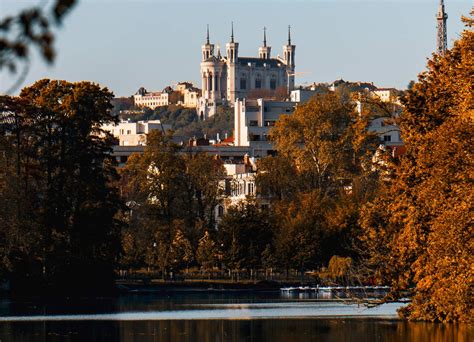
[257,93,379,275]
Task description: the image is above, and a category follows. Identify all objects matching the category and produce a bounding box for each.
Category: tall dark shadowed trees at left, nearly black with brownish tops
[0,80,121,291]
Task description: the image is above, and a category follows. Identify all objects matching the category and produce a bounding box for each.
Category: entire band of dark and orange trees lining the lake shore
[0,14,474,321]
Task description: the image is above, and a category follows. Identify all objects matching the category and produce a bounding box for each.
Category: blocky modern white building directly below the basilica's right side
[234,99,296,157]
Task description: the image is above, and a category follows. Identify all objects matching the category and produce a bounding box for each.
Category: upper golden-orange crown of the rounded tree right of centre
[271,93,377,194]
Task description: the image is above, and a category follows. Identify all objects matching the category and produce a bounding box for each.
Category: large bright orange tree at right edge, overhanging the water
[363,14,474,322]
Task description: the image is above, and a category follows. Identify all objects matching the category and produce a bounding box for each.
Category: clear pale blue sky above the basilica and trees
[0,0,473,96]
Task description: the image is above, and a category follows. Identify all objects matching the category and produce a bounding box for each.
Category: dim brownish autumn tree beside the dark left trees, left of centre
[121,131,224,274]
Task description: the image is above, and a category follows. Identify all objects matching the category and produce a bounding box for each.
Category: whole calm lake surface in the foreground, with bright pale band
[0,291,473,342]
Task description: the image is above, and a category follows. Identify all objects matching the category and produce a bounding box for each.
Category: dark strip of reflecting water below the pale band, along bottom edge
[0,319,473,342]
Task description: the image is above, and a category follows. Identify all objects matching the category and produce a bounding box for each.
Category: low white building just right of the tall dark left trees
[101,120,171,146]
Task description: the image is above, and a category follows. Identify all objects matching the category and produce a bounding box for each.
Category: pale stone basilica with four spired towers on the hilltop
[197,26,296,119]
